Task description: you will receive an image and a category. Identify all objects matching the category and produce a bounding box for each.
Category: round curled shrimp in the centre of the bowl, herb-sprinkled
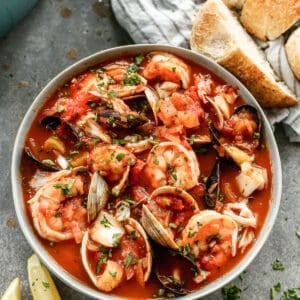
[143,142,200,190]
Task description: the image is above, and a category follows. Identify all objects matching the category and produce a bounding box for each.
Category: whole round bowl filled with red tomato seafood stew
[12,45,282,299]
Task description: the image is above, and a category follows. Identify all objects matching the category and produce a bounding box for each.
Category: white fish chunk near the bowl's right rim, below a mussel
[236,162,268,197]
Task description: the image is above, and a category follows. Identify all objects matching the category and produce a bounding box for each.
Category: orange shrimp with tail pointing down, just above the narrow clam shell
[90,145,136,196]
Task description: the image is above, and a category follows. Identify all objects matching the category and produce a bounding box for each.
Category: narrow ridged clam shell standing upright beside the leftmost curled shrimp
[87,172,109,222]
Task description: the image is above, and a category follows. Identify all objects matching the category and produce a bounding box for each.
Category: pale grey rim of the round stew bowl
[11,44,282,300]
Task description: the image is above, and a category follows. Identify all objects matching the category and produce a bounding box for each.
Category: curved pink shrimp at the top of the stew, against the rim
[143,52,191,89]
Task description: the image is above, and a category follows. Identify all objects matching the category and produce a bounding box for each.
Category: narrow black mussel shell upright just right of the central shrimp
[204,159,222,209]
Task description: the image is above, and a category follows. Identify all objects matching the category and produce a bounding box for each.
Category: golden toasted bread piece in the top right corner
[240,0,300,41]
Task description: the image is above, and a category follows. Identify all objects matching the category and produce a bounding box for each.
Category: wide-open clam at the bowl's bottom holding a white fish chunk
[81,211,152,292]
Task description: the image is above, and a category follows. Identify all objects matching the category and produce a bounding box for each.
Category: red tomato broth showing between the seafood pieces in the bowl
[20,52,272,299]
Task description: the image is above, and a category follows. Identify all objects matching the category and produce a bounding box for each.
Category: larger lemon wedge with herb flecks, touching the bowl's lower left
[27,254,61,300]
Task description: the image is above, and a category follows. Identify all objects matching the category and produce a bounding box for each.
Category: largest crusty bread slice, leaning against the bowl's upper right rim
[190,0,298,107]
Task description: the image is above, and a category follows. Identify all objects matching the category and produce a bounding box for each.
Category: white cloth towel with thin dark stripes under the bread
[111,0,300,142]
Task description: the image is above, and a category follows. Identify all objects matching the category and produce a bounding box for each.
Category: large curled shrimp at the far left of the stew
[29,171,87,243]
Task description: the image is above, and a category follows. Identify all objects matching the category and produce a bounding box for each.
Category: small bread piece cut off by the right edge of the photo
[285,27,300,80]
